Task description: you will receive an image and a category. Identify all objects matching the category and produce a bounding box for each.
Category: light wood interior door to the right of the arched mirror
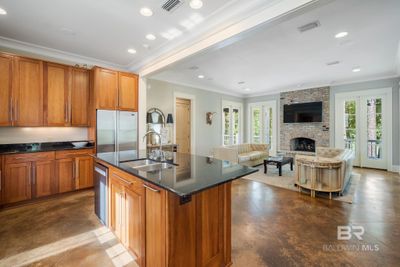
[175,98,192,154]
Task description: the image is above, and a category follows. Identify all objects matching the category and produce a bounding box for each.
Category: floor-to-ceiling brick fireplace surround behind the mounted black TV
[279,87,330,154]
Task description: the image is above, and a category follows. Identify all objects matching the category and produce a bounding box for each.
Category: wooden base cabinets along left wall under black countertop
[0,149,93,205]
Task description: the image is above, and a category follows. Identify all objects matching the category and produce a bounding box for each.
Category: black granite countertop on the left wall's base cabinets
[0,141,94,155]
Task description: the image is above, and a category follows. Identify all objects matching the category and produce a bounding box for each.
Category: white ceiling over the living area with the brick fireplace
[151,0,400,95]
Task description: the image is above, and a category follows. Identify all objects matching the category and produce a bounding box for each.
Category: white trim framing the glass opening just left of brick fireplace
[247,100,279,155]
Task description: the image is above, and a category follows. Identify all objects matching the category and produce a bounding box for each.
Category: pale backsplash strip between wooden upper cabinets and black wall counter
[0,127,88,144]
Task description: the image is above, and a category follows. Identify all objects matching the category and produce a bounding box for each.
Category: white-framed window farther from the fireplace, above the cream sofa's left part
[222,101,243,146]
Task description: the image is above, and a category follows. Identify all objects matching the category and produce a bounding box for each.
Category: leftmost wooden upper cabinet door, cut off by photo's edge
[0,54,12,126]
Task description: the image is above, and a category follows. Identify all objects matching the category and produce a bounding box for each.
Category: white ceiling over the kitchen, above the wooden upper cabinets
[0,0,280,70]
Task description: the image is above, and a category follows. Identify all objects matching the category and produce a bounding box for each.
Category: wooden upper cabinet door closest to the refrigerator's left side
[70,68,90,126]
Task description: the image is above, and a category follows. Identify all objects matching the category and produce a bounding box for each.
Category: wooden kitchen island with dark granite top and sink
[95,153,257,267]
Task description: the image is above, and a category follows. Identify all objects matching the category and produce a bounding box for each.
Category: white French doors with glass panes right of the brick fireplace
[335,89,391,169]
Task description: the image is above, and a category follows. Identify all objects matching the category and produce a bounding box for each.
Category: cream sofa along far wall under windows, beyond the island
[214,144,269,166]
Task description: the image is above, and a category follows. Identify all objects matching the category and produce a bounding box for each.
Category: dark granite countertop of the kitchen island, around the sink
[94,151,258,197]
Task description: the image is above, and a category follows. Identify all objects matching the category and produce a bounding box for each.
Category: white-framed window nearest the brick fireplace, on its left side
[249,101,277,155]
